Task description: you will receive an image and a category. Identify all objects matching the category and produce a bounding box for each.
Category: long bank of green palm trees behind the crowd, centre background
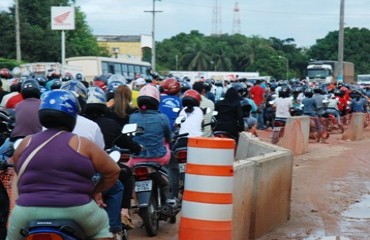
[156,31,307,79]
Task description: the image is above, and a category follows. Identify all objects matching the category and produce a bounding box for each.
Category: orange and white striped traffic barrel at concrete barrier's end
[179,137,235,240]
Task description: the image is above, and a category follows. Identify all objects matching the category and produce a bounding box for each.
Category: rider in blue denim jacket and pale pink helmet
[127,85,180,204]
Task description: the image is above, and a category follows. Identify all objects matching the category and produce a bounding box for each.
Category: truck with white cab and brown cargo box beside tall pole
[306,60,355,84]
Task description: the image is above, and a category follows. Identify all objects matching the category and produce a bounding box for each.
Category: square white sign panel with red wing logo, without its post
[51,7,75,30]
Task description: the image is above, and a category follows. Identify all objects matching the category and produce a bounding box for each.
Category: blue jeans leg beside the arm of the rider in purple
[103,180,123,233]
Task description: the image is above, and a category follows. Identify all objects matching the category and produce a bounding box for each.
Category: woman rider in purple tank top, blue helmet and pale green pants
[8,90,120,240]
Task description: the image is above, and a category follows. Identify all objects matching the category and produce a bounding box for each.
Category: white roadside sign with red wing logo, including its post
[51,7,75,77]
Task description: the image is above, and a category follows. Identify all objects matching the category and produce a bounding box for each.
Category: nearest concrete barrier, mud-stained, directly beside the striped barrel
[233,133,293,239]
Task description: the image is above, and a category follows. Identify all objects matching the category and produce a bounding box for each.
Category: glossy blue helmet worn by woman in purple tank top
[39,90,80,132]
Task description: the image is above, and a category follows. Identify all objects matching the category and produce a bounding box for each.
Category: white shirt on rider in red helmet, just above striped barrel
[179,107,204,137]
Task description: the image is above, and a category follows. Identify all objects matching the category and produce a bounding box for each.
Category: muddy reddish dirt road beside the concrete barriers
[130,129,370,240]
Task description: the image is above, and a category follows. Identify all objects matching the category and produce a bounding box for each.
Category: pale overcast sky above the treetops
[0,0,370,47]
